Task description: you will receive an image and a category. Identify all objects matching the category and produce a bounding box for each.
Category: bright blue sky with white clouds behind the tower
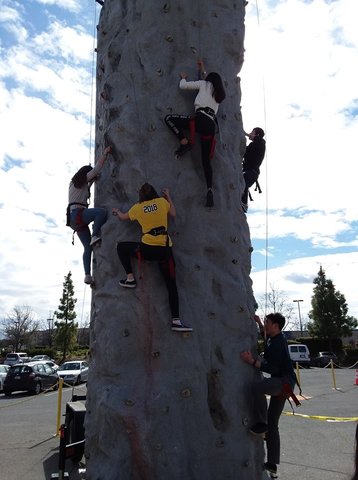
[0,0,358,330]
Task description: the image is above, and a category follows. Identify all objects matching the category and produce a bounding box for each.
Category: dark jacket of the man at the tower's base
[260,332,296,387]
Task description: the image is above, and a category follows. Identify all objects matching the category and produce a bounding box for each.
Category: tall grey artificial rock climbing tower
[86,0,263,480]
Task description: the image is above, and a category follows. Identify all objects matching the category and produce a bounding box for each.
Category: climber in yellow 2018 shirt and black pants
[112,183,192,332]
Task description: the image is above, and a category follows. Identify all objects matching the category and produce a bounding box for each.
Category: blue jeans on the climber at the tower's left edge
[71,208,107,275]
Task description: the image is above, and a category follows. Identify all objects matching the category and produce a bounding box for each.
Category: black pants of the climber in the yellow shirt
[117,242,179,318]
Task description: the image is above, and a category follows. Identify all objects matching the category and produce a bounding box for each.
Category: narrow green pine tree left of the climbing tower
[55,272,78,360]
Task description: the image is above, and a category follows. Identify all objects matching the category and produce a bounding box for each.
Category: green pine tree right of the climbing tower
[308,266,357,350]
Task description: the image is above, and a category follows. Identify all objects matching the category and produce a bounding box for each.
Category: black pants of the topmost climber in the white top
[164,112,215,188]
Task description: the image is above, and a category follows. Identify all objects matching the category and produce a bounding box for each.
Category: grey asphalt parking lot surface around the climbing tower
[0,368,358,480]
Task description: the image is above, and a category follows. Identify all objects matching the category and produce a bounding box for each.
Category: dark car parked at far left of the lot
[4,362,58,395]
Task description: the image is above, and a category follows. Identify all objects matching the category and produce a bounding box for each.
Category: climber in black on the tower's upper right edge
[241,127,266,213]
